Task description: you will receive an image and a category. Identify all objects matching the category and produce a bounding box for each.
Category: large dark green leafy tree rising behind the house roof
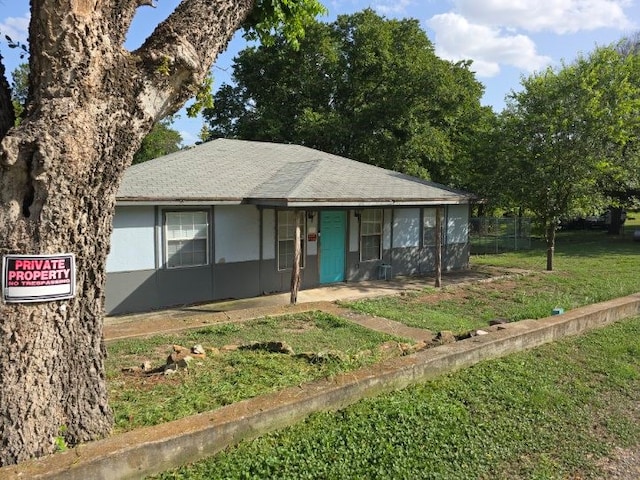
[204,10,490,183]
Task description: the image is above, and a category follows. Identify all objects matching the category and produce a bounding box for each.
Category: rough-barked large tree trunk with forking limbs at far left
[0,0,254,465]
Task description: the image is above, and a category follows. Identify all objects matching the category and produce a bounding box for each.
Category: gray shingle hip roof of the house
[118,139,473,207]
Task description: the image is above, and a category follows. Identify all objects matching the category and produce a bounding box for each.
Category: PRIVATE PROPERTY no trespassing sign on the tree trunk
[2,253,76,302]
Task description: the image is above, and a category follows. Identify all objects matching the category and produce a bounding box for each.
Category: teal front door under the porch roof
[320,212,347,283]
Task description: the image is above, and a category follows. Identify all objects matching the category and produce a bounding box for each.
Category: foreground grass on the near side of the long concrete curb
[154,318,640,479]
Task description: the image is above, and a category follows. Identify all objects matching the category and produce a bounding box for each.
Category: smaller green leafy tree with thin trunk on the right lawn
[498,41,640,270]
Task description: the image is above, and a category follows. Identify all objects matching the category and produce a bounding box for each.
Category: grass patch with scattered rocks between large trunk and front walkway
[106,312,402,432]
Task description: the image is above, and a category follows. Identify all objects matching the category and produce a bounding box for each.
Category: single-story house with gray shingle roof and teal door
[106,139,473,314]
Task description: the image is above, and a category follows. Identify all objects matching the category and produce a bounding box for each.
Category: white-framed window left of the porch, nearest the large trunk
[163,210,210,269]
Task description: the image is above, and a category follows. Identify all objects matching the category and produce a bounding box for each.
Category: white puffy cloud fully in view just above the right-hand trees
[428,13,551,77]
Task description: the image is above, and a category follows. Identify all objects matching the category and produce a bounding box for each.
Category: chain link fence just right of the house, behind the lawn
[469,217,531,254]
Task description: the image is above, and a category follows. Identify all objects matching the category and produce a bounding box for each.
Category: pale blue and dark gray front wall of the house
[106,205,469,314]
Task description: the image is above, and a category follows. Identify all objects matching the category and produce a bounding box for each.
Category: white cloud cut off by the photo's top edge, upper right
[454,0,634,34]
